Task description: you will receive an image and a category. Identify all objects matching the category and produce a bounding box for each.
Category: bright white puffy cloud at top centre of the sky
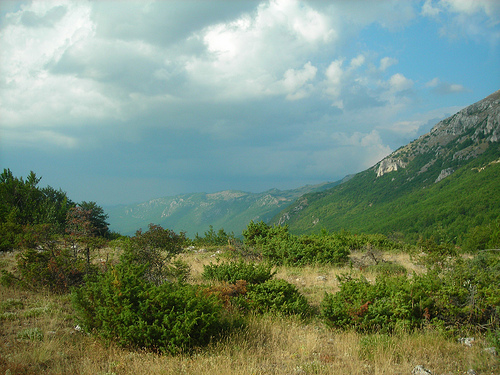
[186,0,336,99]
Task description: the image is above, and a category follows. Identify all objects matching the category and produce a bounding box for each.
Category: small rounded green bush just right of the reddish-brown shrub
[246,279,313,317]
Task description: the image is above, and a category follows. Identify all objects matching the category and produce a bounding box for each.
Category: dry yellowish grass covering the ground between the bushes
[0,251,500,375]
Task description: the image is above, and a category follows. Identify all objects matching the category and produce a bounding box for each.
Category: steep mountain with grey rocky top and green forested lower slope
[271,91,500,242]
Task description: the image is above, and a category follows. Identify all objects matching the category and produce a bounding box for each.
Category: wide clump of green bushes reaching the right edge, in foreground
[321,253,500,332]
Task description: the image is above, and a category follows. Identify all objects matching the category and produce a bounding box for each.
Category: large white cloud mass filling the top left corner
[0,1,130,136]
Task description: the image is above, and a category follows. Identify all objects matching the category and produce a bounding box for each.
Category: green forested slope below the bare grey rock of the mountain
[274,147,500,240]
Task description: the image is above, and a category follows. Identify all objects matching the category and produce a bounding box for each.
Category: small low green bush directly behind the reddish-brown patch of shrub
[202,261,276,284]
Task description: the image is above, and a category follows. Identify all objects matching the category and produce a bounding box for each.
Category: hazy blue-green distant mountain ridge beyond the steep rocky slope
[104,182,340,237]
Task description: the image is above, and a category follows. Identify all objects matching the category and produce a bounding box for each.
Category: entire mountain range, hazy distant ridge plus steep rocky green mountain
[105,91,500,241]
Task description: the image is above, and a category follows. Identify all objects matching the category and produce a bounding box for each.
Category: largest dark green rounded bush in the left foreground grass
[73,262,240,353]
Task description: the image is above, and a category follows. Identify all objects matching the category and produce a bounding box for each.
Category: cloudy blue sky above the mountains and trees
[0,0,500,206]
